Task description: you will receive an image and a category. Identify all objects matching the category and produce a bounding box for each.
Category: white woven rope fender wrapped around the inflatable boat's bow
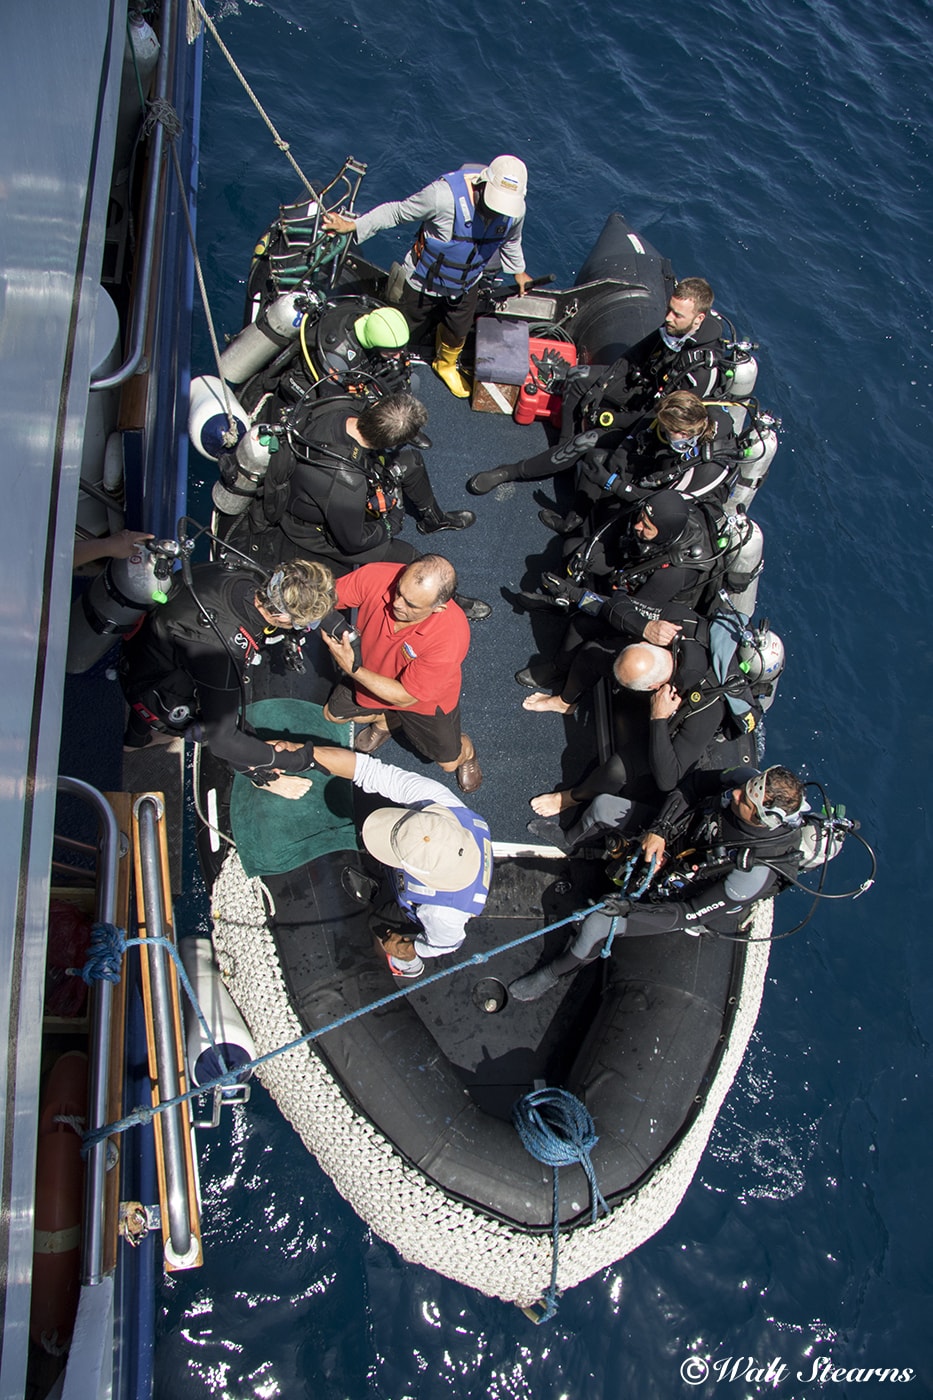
[213,851,772,1308]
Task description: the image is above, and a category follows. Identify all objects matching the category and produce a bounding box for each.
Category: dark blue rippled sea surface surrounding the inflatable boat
[157,0,933,1400]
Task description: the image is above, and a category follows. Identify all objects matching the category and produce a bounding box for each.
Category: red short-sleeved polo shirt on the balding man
[330,564,469,714]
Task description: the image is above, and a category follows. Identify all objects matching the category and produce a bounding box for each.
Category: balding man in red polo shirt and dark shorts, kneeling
[321,554,483,792]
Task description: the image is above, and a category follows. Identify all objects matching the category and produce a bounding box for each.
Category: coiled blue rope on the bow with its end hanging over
[511,1089,609,1322]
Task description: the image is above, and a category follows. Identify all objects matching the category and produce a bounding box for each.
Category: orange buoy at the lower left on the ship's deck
[29,1050,87,1351]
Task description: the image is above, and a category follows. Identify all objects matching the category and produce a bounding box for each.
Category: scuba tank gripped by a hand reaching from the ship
[64,539,179,675]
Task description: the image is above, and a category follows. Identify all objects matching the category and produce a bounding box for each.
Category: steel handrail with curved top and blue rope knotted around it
[59,777,119,1284]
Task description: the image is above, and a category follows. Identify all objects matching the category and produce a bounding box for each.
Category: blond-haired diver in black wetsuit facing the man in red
[120,560,330,785]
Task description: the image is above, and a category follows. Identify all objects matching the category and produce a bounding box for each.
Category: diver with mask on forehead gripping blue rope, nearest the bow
[509,767,807,1001]
